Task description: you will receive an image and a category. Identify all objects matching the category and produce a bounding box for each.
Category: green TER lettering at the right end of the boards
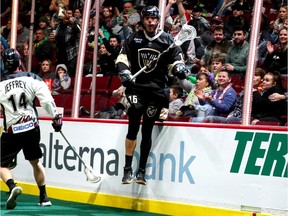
[230,132,288,178]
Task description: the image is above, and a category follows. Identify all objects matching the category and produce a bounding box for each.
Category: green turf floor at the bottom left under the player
[0,191,165,216]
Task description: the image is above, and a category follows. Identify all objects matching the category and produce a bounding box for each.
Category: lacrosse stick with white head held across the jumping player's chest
[131,23,197,80]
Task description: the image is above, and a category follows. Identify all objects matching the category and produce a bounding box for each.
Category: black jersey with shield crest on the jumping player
[116,31,184,105]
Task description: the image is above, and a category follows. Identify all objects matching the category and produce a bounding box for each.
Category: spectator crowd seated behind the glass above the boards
[0,0,288,125]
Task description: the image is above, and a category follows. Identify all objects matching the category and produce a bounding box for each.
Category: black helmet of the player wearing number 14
[3,48,21,73]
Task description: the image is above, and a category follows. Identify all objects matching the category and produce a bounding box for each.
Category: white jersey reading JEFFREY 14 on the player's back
[0,72,58,130]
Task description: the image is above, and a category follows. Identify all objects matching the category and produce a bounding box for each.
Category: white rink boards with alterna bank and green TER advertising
[6,120,288,212]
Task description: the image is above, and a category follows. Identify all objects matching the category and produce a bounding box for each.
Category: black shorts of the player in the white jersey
[0,127,42,167]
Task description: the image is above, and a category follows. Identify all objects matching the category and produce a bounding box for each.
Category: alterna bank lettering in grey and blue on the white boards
[40,133,195,184]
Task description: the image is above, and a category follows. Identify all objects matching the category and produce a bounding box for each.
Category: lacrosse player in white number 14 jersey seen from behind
[0,49,62,209]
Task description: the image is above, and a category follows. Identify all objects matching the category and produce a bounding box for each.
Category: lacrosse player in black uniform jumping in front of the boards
[116,6,189,185]
